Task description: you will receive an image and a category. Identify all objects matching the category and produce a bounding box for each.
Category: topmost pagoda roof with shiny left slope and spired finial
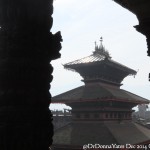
[63,39,136,76]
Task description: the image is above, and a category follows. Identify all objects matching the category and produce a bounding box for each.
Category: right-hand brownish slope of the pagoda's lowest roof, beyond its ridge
[105,122,150,144]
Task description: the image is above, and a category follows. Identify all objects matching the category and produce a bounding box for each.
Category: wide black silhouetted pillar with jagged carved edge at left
[0,0,61,150]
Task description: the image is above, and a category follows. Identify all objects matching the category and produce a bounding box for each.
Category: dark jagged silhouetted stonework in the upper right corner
[114,0,150,81]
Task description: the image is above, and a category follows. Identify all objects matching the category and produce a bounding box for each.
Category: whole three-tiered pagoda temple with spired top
[52,38,150,150]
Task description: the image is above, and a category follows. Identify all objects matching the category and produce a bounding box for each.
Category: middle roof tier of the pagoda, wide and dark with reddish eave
[52,84,150,104]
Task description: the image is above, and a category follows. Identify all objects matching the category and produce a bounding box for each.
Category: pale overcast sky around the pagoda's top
[50,0,150,110]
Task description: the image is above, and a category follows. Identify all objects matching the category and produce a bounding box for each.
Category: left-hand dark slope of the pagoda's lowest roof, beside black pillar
[53,123,117,145]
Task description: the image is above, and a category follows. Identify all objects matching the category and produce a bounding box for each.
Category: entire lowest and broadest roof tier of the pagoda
[53,121,150,147]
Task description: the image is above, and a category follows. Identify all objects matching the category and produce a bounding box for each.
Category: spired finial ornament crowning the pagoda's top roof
[93,37,111,58]
